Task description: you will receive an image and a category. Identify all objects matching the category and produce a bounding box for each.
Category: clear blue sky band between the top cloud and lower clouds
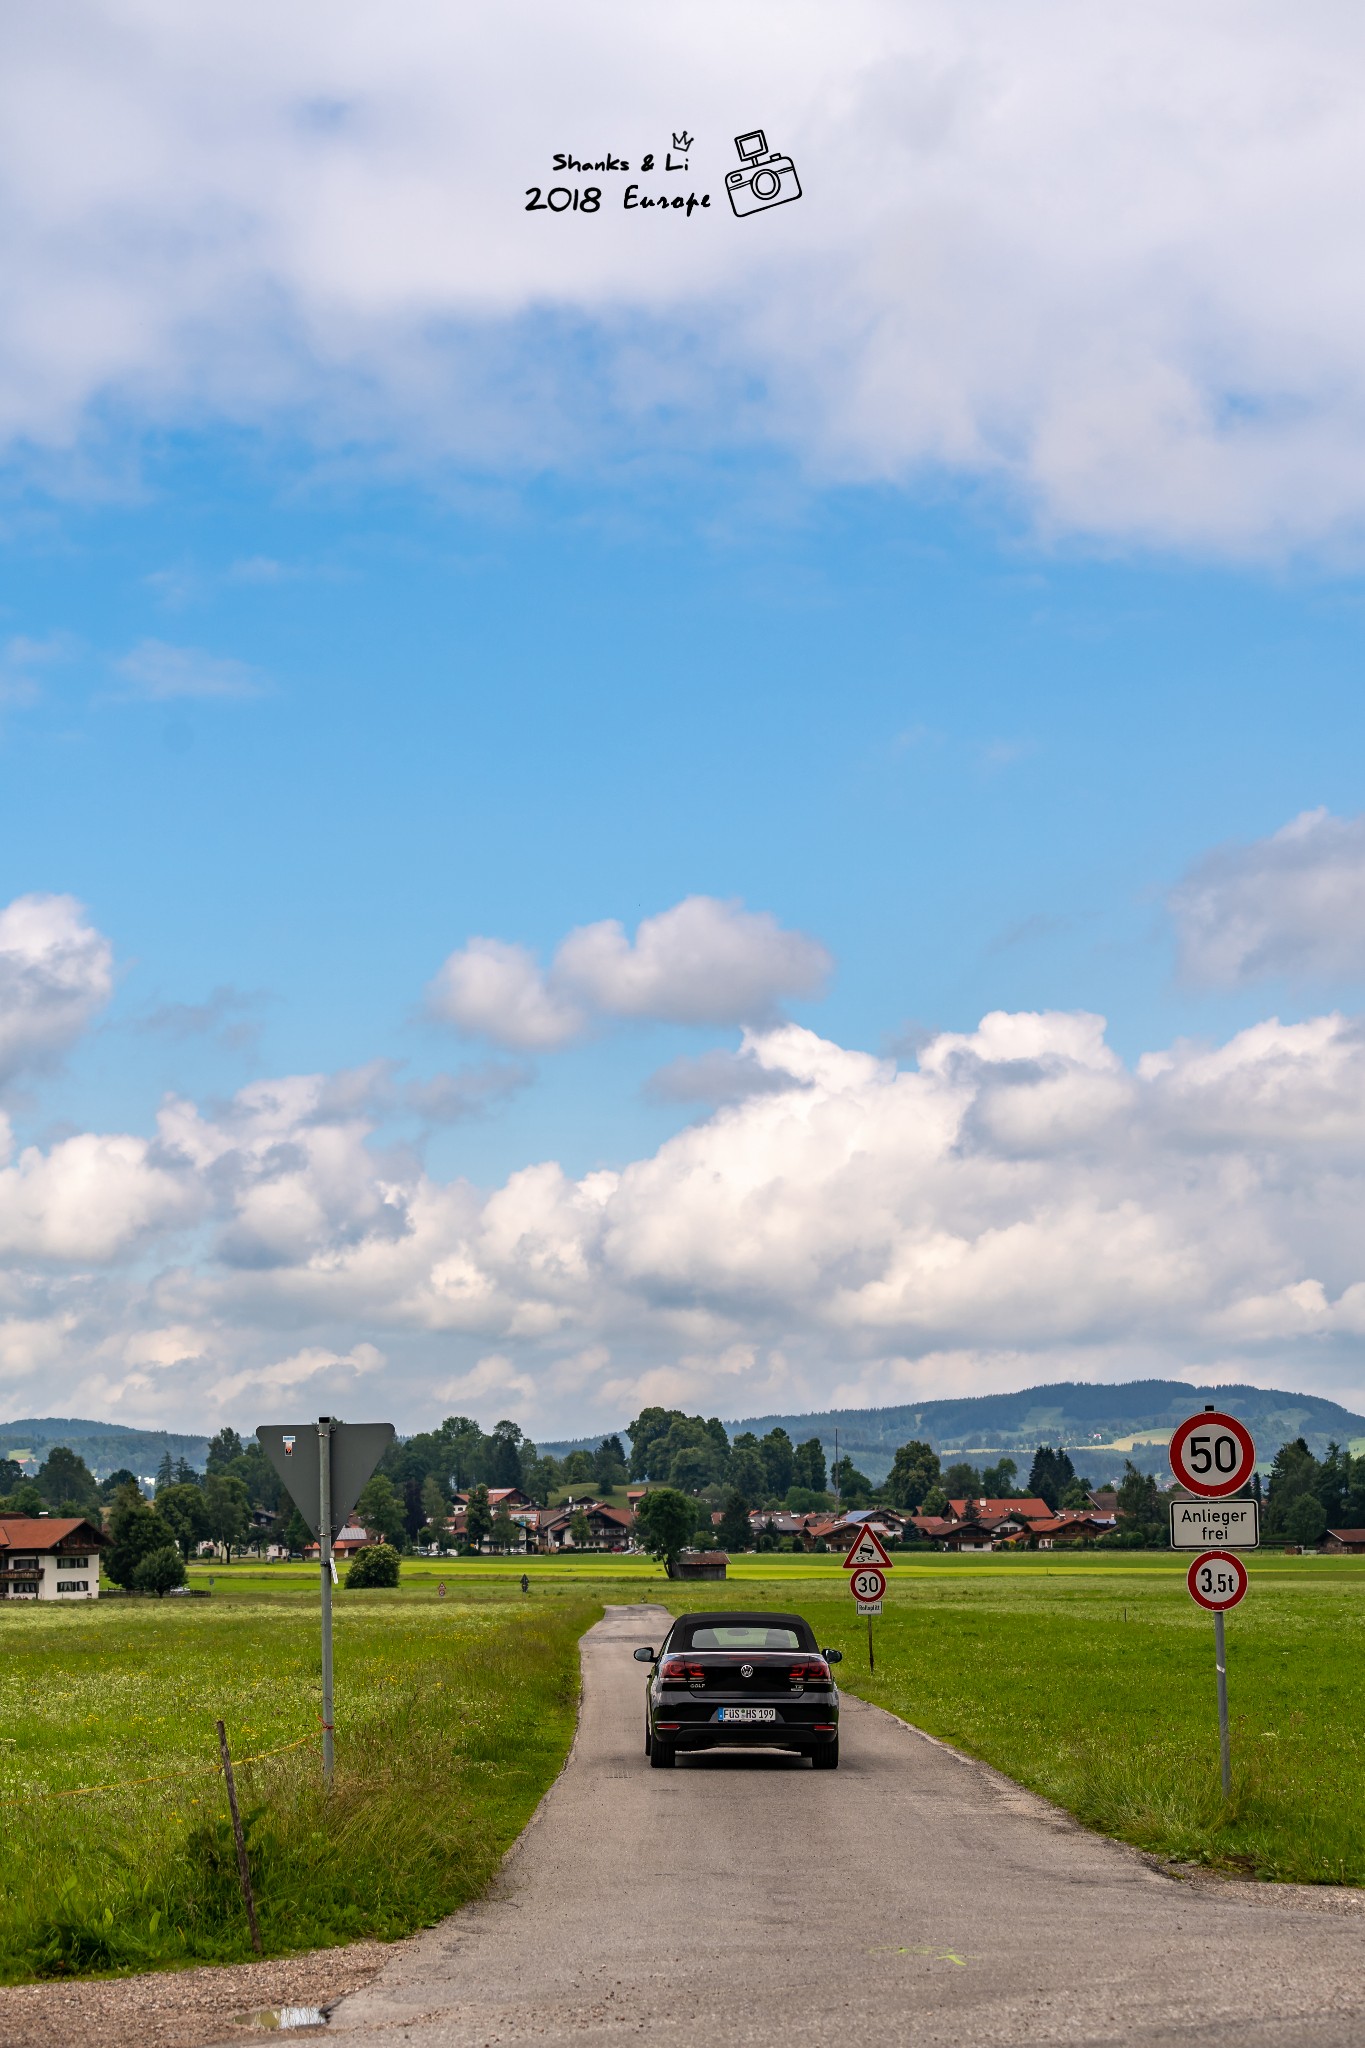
[0,462,1365,1180]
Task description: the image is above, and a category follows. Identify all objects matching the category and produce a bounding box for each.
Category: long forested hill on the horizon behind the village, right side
[726,1380,1365,1481]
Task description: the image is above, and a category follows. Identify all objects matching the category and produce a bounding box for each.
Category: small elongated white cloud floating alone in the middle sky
[428,897,833,1051]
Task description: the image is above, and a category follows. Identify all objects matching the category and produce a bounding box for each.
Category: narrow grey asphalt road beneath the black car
[332,1608,1365,2048]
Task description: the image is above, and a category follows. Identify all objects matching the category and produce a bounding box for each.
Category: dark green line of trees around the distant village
[0,1407,1365,1564]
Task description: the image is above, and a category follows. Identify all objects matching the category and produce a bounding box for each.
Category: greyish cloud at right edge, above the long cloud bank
[1171,809,1365,989]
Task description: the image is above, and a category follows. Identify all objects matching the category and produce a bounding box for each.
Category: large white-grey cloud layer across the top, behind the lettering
[0,0,1365,549]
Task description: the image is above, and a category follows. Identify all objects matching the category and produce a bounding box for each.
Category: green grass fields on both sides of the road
[0,1554,1365,1982]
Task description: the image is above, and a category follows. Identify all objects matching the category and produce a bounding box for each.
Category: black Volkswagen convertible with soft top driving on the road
[634,1614,843,1772]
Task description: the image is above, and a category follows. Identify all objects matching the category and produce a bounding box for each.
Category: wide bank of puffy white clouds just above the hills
[0,1014,1365,1434]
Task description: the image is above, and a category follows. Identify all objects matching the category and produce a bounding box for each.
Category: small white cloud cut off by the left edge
[0,895,115,1085]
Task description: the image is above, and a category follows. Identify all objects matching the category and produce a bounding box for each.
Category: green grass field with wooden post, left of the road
[0,1571,602,1982]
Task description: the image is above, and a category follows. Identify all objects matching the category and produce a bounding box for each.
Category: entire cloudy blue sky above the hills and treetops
[0,0,1365,1436]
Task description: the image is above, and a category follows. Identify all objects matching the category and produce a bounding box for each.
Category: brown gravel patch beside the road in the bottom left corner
[0,1942,393,2048]
